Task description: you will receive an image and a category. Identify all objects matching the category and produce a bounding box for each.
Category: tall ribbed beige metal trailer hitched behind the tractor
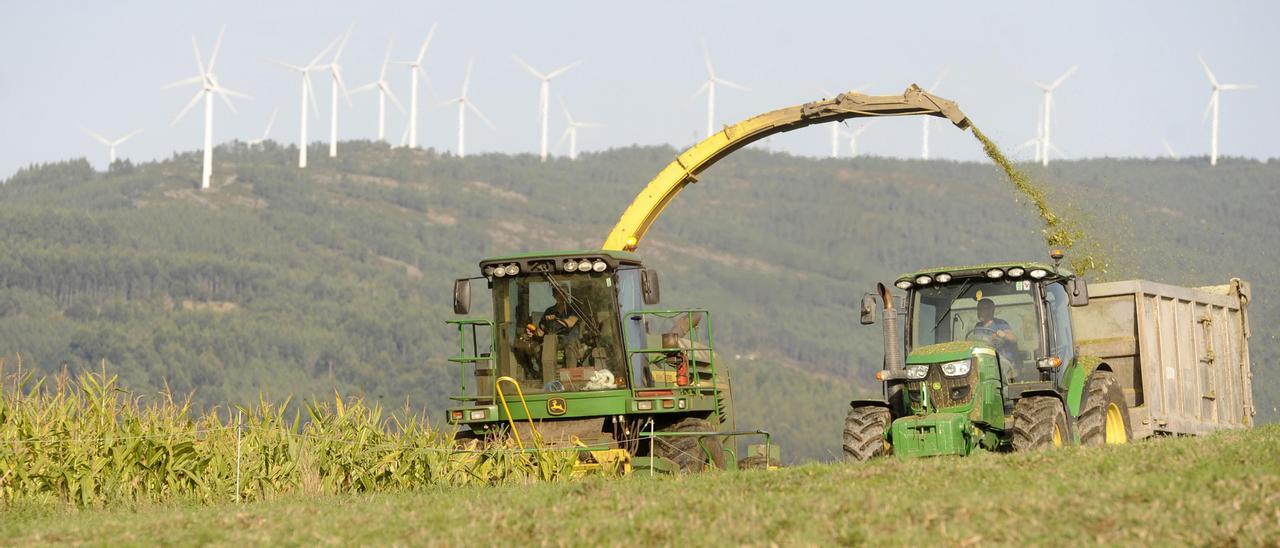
[1071,278,1257,438]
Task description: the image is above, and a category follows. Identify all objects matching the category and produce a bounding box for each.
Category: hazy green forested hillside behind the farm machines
[0,142,1280,458]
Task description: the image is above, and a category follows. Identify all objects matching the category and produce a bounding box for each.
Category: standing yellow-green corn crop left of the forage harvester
[0,361,577,508]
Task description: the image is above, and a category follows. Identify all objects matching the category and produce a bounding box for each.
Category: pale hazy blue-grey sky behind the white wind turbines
[0,0,1280,177]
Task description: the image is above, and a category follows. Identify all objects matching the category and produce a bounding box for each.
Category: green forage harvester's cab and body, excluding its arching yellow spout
[445,250,777,471]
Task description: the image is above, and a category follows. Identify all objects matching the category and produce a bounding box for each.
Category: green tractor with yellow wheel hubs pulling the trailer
[844,251,1133,461]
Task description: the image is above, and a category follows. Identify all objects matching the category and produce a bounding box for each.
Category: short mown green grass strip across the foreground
[0,425,1280,545]
